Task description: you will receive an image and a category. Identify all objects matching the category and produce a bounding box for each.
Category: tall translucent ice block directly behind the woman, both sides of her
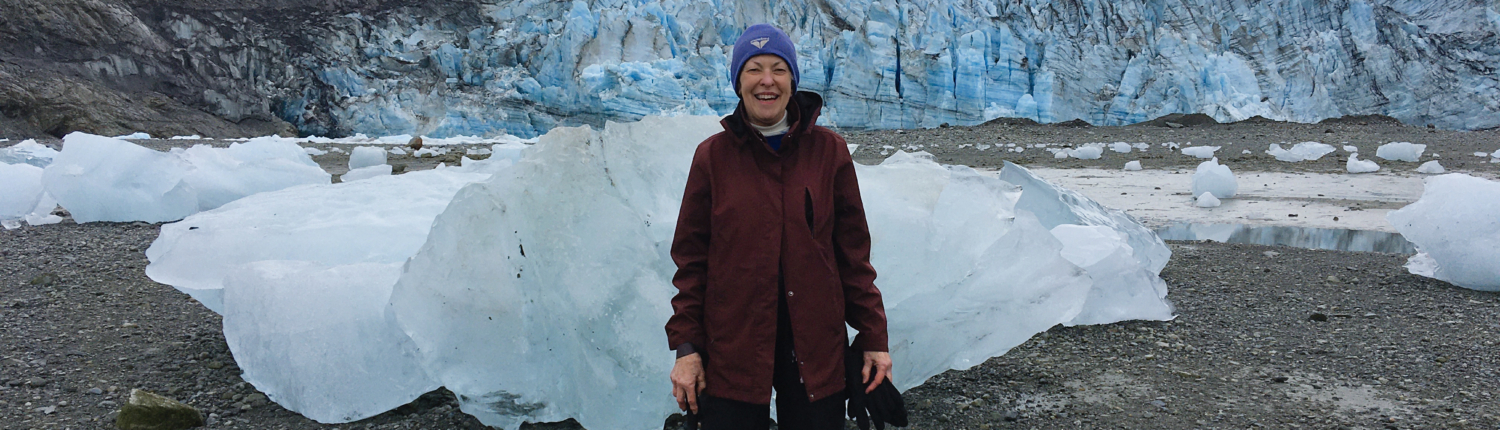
[392,118,1170,429]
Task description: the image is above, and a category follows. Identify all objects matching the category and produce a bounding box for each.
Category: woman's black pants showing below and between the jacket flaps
[698,274,845,430]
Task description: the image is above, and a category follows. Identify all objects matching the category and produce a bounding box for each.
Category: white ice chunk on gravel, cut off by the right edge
[1386,174,1500,291]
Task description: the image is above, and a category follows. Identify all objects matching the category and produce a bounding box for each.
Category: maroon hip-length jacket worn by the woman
[666,91,888,405]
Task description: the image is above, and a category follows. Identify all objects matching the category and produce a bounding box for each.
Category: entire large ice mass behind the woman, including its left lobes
[147,115,1173,429]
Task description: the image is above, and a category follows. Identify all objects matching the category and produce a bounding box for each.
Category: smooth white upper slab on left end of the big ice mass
[146,169,489,313]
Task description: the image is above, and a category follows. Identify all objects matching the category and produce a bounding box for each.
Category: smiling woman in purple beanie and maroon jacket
[666,24,891,430]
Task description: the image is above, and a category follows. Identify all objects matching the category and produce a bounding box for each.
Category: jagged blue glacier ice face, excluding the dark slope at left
[276,0,1500,135]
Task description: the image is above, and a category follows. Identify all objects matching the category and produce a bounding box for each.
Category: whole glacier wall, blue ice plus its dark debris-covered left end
[0,0,1500,136]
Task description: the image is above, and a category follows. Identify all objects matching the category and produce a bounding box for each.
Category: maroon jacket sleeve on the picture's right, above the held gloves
[834,138,890,351]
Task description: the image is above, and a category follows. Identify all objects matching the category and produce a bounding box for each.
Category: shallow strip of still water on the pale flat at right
[1157,223,1416,253]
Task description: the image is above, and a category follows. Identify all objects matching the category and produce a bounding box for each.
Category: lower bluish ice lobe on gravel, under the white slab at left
[224,261,441,423]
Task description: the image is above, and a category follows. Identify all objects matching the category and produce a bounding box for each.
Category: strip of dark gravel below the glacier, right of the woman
[843,115,1500,174]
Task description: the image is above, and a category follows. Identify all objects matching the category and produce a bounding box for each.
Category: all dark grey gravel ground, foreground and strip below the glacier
[0,118,1500,429]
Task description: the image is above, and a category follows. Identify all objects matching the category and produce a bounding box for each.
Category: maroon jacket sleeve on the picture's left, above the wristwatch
[666,141,713,351]
